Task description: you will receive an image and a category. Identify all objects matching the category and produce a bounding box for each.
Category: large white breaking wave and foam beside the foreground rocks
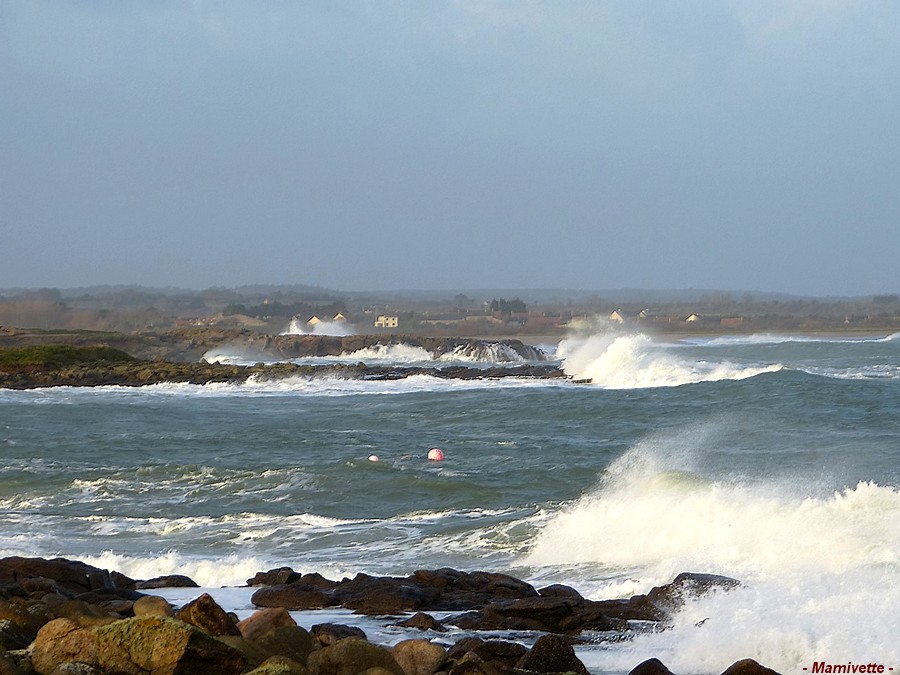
[524,443,900,672]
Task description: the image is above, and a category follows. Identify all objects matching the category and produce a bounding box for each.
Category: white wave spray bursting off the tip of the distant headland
[556,333,782,389]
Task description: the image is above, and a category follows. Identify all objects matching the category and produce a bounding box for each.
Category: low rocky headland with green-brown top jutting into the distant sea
[0,329,565,389]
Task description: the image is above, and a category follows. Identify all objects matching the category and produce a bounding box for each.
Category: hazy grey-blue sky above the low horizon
[0,0,900,296]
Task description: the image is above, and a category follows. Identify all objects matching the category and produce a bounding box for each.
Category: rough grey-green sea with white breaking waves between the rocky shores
[0,326,900,675]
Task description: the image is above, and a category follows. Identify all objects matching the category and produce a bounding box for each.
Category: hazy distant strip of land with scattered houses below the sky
[0,286,900,337]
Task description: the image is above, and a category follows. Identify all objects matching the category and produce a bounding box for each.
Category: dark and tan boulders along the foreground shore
[0,557,774,675]
